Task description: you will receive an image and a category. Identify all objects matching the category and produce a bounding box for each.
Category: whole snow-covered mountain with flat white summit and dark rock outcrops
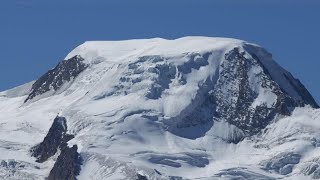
[0,37,320,180]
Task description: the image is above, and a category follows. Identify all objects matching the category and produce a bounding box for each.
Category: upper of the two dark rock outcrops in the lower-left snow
[31,117,73,163]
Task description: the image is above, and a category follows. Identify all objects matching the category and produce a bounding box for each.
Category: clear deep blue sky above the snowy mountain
[0,0,320,102]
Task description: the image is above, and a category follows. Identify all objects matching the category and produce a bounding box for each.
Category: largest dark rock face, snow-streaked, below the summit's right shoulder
[213,48,318,135]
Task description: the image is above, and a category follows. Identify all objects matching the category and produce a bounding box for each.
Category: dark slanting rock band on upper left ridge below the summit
[25,56,87,102]
